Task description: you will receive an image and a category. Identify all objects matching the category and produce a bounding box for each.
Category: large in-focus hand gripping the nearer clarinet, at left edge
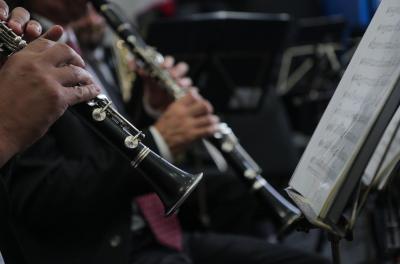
[0,27,100,167]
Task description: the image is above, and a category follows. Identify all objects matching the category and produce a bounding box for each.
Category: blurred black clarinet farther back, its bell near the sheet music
[91,0,301,230]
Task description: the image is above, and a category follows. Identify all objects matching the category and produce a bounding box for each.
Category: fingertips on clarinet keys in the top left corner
[0,0,42,41]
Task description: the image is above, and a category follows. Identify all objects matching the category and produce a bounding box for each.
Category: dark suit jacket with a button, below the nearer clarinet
[5,108,159,264]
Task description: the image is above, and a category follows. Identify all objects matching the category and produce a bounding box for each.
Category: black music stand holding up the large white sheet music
[288,78,400,264]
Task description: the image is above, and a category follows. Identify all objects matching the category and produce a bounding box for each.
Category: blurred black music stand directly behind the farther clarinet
[147,12,290,113]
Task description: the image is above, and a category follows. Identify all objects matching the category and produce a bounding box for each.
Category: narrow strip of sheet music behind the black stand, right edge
[362,108,400,186]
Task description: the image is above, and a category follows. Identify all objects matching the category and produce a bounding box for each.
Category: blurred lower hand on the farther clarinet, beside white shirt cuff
[154,90,219,155]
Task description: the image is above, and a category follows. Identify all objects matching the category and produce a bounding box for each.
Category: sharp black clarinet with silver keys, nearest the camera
[0,22,203,216]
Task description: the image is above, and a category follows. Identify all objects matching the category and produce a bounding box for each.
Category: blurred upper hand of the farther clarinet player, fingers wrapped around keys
[139,56,192,112]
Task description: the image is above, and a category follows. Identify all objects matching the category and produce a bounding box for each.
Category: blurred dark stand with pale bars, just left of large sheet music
[277,16,346,135]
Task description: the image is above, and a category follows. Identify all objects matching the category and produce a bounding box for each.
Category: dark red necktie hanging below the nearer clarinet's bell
[135,193,182,251]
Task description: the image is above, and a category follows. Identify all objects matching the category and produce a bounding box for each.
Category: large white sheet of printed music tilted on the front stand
[290,0,400,218]
